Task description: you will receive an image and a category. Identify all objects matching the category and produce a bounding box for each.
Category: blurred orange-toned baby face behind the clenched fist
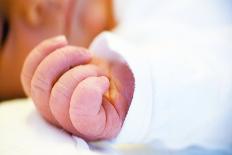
[0,0,114,100]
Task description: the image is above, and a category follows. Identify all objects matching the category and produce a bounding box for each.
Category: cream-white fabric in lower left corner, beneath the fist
[0,99,102,155]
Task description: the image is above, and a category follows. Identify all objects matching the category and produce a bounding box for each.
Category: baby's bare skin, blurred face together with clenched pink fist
[0,0,134,140]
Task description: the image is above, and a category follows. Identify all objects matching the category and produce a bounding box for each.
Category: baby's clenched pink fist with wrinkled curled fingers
[21,37,134,140]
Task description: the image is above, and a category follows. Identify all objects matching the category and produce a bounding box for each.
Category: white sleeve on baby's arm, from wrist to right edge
[89,28,232,150]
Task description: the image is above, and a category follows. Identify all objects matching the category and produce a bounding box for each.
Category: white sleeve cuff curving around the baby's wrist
[90,32,152,143]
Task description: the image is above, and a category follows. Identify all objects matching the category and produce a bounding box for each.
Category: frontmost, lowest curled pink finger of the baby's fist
[69,76,110,139]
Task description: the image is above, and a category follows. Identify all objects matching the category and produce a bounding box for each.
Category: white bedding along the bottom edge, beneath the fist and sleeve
[0,99,231,155]
